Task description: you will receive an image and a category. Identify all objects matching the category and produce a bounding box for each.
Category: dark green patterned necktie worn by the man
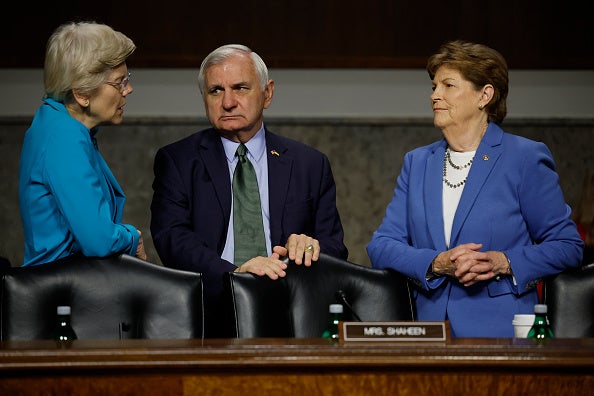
[233,143,266,267]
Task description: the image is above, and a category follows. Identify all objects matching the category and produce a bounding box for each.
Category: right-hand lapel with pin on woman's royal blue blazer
[450,124,503,246]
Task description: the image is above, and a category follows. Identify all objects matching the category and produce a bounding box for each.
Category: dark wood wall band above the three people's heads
[0,0,594,69]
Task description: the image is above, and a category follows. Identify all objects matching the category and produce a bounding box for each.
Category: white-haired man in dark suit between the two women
[151,45,348,337]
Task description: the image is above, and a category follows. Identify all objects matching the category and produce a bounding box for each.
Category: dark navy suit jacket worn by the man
[151,129,348,335]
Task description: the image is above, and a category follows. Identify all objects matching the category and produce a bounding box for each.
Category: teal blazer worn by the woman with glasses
[19,99,139,265]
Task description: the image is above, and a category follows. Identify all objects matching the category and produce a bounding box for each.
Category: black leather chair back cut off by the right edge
[544,263,594,338]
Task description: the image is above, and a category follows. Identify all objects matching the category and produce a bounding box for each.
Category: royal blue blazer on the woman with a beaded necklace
[367,124,583,337]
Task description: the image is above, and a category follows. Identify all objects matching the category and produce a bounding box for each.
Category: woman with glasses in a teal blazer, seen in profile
[19,22,146,265]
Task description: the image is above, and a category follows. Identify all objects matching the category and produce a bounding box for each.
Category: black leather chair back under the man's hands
[224,254,415,338]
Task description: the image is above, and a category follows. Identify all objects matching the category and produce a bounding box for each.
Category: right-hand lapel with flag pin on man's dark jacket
[266,130,293,246]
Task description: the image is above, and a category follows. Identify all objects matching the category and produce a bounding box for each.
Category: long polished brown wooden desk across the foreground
[0,338,594,395]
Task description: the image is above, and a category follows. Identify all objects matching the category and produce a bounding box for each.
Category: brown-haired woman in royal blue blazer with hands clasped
[367,41,583,337]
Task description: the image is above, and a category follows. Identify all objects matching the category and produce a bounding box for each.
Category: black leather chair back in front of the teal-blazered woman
[0,254,204,340]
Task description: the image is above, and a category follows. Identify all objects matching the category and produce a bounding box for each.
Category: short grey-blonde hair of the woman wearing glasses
[43,22,136,102]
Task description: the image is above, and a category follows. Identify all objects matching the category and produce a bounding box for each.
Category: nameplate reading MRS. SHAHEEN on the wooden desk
[339,321,449,342]
